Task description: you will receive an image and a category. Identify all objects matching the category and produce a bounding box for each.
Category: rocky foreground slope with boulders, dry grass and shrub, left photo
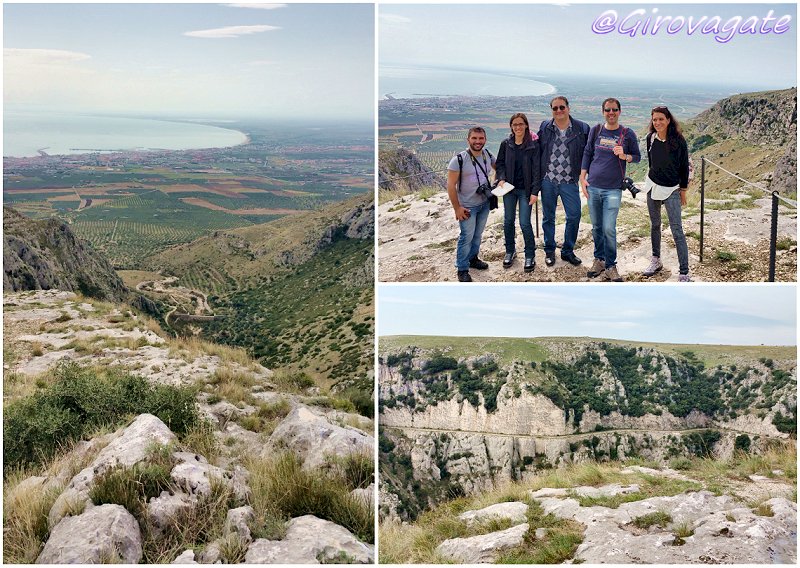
[3,290,374,564]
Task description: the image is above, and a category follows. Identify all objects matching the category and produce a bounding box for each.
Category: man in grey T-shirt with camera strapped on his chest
[447,126,495,282]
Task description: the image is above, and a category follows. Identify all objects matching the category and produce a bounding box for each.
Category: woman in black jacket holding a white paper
[497,112,542,272]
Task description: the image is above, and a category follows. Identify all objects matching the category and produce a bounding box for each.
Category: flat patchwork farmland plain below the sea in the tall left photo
[3,118,373,272]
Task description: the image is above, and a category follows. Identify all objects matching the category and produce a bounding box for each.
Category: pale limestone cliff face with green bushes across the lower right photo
[379,339,797,518]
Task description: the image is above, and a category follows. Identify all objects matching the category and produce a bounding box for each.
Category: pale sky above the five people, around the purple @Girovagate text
[378,3,797,91]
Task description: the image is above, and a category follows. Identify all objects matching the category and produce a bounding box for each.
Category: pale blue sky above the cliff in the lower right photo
[378,284,797,345]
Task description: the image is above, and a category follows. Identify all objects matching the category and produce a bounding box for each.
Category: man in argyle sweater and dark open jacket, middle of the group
[539,95,589,266]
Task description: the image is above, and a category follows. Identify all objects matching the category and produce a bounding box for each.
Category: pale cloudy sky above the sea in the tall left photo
[3,3,374,120]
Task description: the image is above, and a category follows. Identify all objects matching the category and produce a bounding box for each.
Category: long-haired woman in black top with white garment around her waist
[642,106,690,282]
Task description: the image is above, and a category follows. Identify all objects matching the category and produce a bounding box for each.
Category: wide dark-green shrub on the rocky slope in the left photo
[3,363,198,474]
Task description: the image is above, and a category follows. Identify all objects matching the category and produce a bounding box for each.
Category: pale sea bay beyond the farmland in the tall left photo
[3,110,247,158]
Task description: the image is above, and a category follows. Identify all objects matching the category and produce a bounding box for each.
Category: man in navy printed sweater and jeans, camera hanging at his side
[579,98,641,282]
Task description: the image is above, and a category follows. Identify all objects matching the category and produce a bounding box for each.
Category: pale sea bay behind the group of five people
[378,66,556,99]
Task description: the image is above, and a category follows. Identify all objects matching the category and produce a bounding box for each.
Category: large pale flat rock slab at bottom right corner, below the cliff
[537,488,797,564]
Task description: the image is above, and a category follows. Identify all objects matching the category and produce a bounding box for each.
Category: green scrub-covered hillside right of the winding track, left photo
[145,196,375,394]
